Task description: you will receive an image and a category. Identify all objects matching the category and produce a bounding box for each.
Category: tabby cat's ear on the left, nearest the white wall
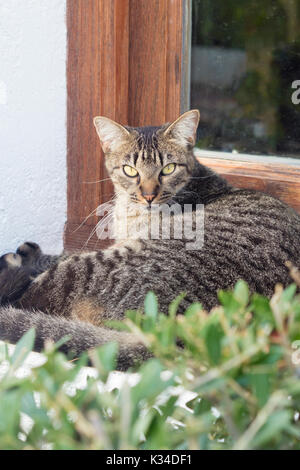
[94,116,130,153]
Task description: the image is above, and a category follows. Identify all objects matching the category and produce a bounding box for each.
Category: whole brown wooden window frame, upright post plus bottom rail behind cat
[64,0,300,250]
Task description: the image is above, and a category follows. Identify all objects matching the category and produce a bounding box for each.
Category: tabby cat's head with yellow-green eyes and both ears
[94,110,200,206]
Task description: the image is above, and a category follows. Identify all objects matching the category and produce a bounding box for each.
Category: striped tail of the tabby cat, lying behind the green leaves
[0,306,151,370]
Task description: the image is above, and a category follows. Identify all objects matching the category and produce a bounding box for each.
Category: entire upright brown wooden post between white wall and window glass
[65,0,186,252]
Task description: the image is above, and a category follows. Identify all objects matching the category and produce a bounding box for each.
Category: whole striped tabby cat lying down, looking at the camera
[0,110,300,370]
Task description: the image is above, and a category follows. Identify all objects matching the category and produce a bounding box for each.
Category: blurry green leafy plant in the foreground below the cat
[0,281,300,449]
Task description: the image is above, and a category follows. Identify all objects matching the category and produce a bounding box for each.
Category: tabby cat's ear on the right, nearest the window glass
[164,109,200,147]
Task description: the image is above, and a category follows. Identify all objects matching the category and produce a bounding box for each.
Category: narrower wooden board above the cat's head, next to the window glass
[129,0,184,126]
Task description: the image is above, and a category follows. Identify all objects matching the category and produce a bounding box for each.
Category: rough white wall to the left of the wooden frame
[0,0,66,254]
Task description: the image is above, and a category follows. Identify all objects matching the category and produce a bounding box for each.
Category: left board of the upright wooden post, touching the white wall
[65,0,129,243]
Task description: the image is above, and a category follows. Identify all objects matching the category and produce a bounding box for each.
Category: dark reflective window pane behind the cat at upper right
[191,0,300,158]
